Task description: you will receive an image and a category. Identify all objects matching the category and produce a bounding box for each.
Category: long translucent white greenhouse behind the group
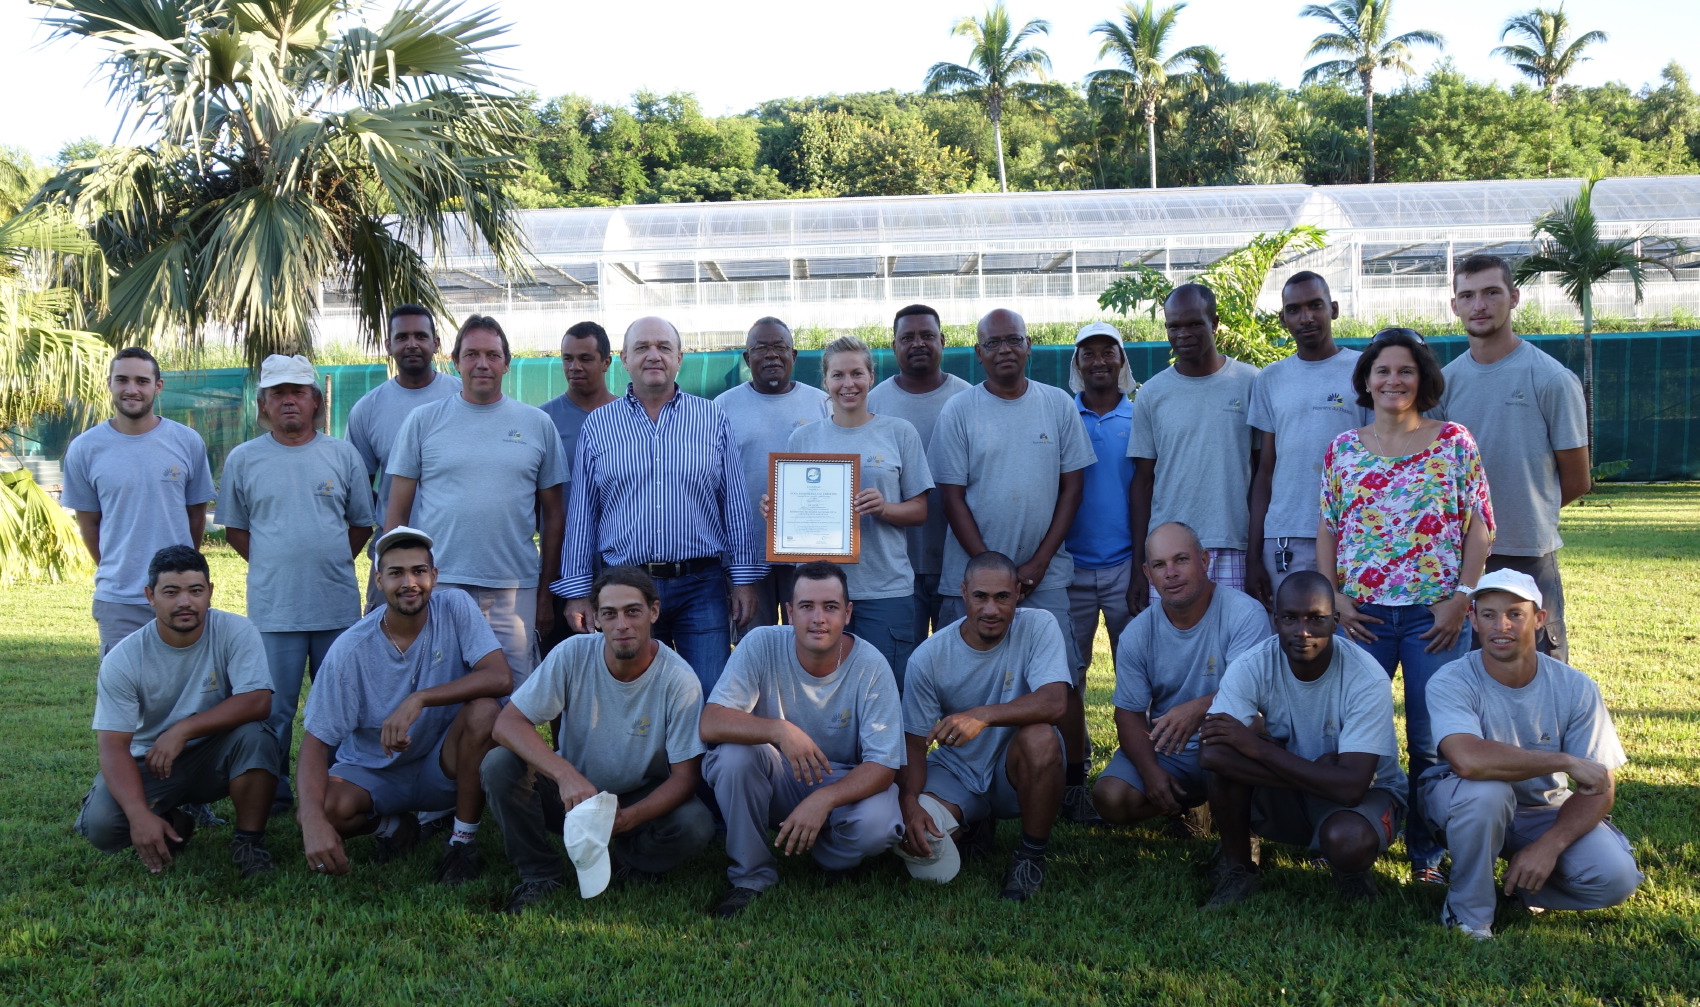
[321,175,1700,349]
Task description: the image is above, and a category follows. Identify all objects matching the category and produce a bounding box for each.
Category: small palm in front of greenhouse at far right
[1513,174,1686,458]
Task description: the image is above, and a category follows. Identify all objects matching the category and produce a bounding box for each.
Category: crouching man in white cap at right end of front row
[1418,570,1641,941]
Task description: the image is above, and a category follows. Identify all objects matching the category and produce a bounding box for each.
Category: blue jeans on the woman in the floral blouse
[1358,604,1471,868]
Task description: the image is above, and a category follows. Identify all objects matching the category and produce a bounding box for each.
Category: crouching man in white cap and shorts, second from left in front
[296,526,513,885]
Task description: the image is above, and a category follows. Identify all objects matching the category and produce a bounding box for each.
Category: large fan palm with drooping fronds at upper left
[37,0,524,362]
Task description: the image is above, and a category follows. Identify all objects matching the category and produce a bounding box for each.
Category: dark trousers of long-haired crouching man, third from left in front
[479,747,714,881]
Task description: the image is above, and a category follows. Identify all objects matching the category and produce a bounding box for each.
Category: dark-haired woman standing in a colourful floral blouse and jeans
[1316,328,1493,885]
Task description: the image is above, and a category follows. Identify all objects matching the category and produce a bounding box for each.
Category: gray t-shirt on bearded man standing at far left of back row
[60,417,213,606]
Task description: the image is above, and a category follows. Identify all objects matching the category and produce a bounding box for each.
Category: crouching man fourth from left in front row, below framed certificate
[702,563,903,919]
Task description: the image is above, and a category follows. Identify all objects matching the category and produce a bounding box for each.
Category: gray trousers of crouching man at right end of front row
[1423,774,1642,929]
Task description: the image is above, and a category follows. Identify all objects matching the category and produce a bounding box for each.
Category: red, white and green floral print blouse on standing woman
[1323,424,1493,606]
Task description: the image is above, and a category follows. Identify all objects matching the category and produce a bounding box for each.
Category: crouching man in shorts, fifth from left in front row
[899,551,1074,902]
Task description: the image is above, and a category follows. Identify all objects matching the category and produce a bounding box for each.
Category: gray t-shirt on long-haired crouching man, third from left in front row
[513,633,704,794]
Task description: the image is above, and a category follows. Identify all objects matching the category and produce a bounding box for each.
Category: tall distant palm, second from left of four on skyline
[1086,0,1222,189]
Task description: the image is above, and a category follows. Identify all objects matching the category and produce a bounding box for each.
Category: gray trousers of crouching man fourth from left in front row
[702,743,903,891]
